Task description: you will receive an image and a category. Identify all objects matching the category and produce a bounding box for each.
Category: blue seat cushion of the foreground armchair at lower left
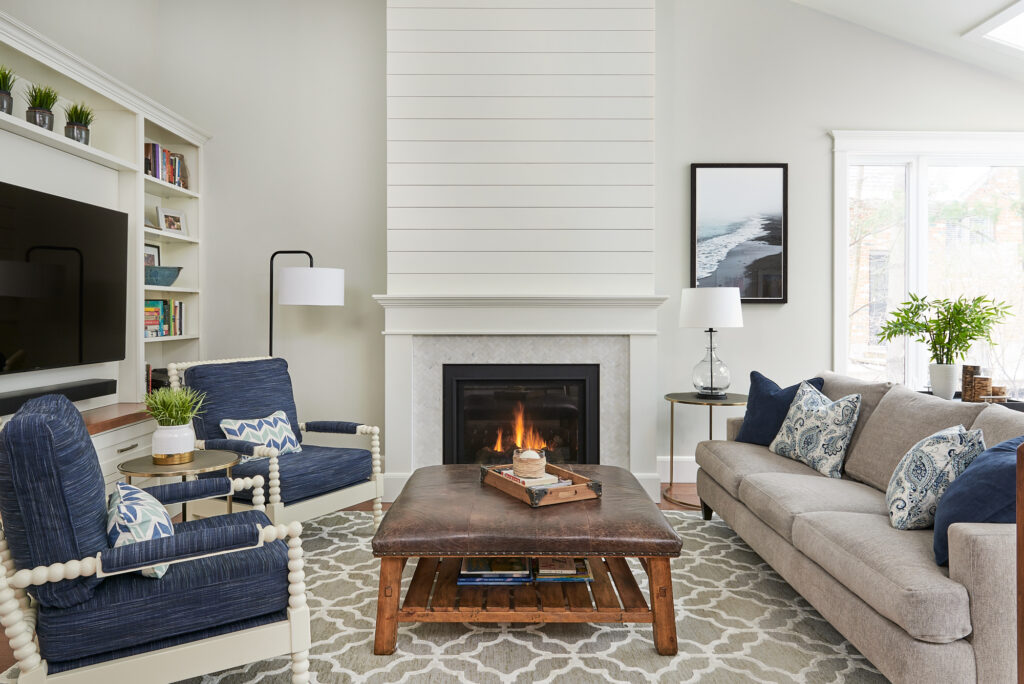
[37,511,288,661]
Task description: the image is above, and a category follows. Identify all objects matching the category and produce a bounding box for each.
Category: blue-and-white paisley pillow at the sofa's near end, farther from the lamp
[886,425,985,529]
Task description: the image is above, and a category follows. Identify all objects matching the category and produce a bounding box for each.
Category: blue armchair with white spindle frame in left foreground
[0,395,310,684]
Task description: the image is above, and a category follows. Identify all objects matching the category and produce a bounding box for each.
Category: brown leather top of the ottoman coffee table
[373,465,682,556]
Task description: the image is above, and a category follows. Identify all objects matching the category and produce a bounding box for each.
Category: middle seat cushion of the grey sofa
[739,473,886,542]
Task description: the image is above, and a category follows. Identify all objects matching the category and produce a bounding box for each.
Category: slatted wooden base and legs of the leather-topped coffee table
[374,556,678,655]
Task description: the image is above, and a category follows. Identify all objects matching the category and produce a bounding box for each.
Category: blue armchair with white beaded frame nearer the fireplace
[167,357,384,525]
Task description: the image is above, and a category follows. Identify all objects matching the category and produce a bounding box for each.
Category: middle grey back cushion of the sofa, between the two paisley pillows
[846,385,987,491]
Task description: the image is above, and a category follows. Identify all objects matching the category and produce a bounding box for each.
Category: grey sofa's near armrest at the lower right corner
[949,522,1017,684]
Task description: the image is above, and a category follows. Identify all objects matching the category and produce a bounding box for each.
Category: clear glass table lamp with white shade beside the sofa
[679,288,743,399]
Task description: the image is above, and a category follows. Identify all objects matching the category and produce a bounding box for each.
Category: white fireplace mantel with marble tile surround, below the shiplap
[375,295,665,500]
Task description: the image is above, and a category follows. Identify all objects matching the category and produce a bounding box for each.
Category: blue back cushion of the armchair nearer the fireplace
[184,358,302,443]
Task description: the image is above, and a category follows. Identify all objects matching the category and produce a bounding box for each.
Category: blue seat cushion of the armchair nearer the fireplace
[200,443,374,505]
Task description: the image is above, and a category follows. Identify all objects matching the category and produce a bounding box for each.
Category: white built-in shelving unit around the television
[0,12,210,401]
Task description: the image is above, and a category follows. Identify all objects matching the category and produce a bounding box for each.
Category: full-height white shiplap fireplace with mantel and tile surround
[377,0,665,498]
